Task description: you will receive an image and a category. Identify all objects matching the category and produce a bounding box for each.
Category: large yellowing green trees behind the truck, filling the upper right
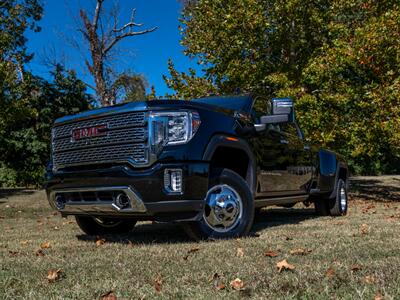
[165,0,400,174]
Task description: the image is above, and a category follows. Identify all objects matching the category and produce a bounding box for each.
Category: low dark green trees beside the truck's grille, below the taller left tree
[0,66,91,186]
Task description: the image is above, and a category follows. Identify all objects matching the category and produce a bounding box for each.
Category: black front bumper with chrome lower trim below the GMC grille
[46,162,209,221]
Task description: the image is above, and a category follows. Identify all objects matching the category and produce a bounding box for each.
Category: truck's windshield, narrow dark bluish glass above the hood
[192,96,253,113]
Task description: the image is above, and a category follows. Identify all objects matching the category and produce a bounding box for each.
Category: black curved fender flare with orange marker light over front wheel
[203,134,257,196]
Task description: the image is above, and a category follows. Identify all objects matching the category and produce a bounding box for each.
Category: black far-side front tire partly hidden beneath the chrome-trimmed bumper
[75,216,136,235]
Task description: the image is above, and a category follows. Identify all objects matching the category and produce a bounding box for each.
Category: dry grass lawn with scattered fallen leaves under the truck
[0,176,400,299]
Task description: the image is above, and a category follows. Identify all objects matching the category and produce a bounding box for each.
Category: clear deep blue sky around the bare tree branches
[27,0,198,95]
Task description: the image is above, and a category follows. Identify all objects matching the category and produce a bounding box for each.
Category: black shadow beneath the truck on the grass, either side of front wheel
[77,208,318,245]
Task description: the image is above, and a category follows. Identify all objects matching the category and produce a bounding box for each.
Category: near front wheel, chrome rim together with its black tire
[184,169,254,240]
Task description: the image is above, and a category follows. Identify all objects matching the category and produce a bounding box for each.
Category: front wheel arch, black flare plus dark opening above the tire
[203,134,257,196]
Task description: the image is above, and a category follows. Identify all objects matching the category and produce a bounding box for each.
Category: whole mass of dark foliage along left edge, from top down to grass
[0,0,91,186]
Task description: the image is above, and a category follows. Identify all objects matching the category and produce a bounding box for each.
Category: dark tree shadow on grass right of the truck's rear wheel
[350,177,400,202]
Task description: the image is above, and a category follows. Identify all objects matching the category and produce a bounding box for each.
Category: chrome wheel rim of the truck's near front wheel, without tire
[203,184,243,233]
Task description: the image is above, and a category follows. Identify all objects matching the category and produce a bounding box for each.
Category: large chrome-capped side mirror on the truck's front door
[255,98,294,131]
